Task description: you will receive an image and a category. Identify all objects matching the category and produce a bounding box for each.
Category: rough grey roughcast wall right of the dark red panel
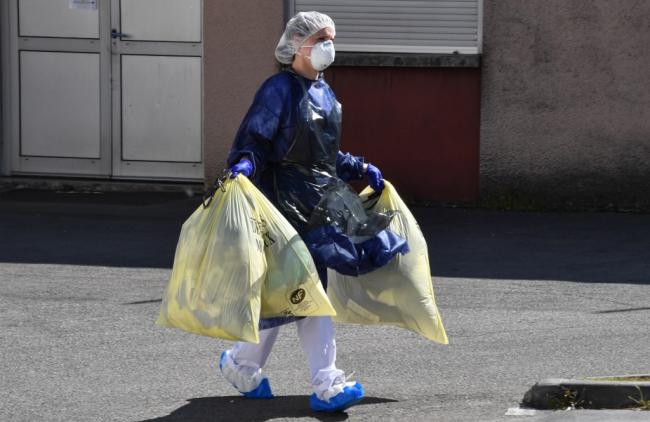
[480,0,650,207]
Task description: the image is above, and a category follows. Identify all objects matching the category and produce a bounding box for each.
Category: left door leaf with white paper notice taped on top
[3,0,111,177]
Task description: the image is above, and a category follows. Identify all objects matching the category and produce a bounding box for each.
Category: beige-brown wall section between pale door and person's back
[203,0,284,183]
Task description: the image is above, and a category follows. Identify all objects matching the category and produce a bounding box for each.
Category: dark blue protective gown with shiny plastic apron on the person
[228,71,408,328]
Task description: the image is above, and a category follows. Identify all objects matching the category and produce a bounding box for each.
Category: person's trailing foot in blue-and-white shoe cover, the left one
[219,350,273,399]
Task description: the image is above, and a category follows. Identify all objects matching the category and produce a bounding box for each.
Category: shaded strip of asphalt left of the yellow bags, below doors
[0,191,201,268]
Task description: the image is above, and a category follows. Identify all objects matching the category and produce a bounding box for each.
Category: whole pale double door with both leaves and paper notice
[2,0,203,180]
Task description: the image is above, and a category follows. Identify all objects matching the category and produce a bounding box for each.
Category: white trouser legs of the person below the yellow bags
[231,317,342,390]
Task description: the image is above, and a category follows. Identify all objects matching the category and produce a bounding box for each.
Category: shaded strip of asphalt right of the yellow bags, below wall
[414,208,650,284]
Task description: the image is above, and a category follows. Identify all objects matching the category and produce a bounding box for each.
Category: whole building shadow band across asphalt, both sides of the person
[0,191,650,284]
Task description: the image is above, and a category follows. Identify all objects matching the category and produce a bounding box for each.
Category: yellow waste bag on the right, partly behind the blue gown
[327,181,449,344]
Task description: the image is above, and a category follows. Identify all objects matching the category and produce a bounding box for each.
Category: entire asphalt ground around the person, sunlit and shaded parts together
[0,191,650,422]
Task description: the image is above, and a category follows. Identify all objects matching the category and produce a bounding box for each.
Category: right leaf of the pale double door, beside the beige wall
[111,0,203,180]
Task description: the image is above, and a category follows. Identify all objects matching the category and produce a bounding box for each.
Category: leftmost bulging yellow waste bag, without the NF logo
[156,177,266,343]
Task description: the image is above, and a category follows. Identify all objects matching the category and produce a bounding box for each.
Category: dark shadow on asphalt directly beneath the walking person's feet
[143,396,397,422]
